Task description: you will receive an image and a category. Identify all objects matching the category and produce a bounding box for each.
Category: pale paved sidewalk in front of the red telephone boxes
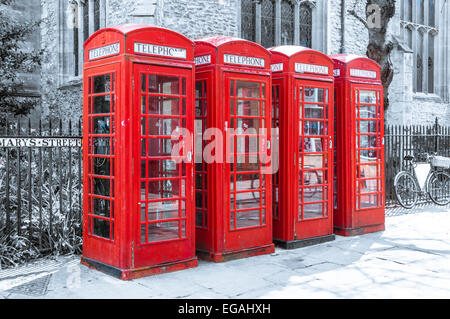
[0,207,450,298]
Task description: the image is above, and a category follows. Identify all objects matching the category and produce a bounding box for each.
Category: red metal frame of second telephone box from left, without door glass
[195,37,274,262]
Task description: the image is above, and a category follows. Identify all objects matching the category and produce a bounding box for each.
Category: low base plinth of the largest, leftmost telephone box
[81,257,198,280]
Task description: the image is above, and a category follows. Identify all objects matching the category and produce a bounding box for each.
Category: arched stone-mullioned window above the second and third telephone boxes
[240,0,316,48]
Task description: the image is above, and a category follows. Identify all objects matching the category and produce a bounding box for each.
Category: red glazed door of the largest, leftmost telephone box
[134,64,195,268]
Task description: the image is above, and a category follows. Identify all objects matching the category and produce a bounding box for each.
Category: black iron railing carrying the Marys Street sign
[0,118,82,264]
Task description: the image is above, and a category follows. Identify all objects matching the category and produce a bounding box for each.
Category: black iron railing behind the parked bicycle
[385,118,450,206]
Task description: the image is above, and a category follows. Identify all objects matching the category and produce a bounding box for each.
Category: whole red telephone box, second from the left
[195,36,274,262]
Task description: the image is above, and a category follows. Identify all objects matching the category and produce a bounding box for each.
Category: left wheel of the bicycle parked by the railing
[394,172,420,209]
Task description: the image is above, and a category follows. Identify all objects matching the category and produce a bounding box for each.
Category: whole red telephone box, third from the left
[270,45,334,249]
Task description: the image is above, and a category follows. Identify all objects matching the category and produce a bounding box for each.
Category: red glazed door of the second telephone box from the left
[224,73,272,251]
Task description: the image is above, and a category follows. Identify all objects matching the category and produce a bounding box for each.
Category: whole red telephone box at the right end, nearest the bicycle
[330,54,385,236]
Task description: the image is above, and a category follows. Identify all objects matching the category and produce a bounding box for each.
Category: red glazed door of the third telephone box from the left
[293,79,333,239]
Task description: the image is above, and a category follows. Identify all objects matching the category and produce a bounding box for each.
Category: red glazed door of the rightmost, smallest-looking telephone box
[351,85,384,225]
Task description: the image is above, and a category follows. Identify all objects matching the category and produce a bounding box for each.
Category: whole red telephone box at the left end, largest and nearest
[82,25,197,279]
